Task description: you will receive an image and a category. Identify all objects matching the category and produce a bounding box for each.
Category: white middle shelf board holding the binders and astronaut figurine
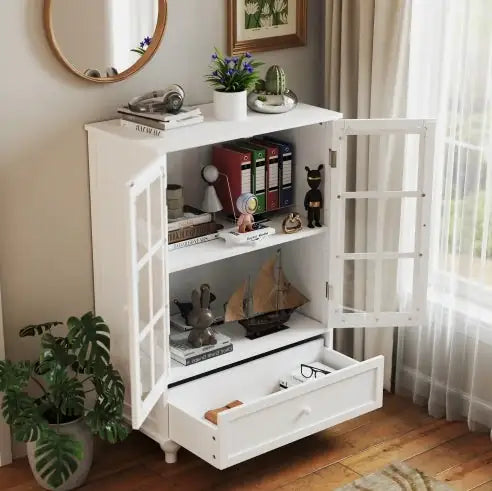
[168,216,328,273]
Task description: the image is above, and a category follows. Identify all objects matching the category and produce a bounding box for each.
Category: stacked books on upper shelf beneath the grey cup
[167,205,222,251]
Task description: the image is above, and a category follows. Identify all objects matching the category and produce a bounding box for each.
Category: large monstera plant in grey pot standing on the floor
[0,312,128,490]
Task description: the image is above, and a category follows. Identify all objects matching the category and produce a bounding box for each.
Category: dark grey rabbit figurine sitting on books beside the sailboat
[188,284,217,348]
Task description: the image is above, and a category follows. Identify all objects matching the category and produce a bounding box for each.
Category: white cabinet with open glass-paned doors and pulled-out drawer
[86,104,434,469]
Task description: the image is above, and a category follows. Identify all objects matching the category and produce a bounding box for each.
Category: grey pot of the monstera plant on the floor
[27,418,94,491]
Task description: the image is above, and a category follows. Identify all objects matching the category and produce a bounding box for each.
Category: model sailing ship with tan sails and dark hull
[224,251,309,339]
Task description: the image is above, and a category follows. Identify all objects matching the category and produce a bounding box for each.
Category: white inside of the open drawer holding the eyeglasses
[169,338,358,426]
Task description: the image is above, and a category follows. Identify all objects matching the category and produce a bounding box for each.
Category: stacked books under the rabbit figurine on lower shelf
[169,327,233,365]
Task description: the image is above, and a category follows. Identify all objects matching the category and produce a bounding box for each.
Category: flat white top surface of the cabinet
[85,104,342,153]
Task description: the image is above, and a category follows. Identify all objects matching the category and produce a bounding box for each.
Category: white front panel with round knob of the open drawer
[218,357,383,467]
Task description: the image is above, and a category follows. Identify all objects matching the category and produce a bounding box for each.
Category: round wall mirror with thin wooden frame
[44,0,167,83]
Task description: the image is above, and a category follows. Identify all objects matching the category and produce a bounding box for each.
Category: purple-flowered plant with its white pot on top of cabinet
[205,48,263,121]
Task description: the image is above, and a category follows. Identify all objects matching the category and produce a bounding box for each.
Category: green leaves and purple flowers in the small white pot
[205,48,263,92]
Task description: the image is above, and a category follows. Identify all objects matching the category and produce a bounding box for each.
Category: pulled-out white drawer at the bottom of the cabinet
[169,339,384,469]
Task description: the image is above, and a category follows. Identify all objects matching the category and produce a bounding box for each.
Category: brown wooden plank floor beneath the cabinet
[0,395,492,491]
